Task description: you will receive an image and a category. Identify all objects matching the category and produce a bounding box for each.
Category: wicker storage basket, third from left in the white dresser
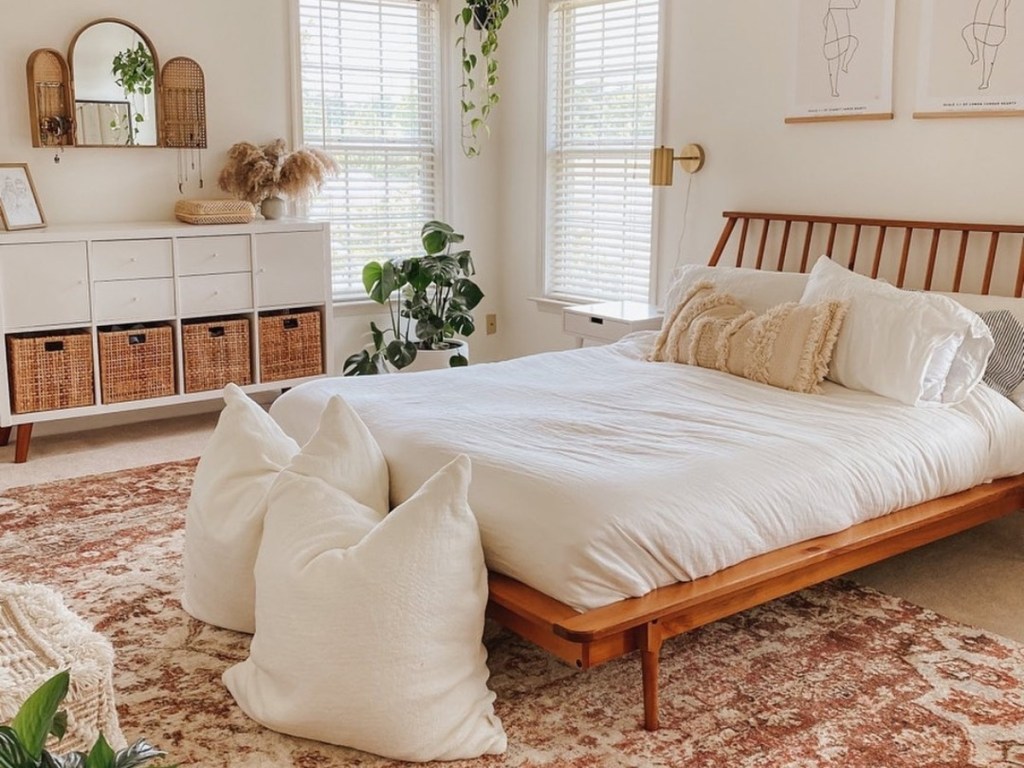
[181,317,253,392]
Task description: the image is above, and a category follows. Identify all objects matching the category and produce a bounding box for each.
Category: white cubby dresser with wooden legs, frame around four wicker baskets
[0,220,334,461]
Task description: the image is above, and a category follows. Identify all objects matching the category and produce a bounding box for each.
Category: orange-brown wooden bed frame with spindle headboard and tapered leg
[487,212,1024,730]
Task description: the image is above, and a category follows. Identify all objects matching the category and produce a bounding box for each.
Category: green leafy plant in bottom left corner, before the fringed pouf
[0,670,165,768]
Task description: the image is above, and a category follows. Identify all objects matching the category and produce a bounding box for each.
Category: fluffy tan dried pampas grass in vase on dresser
[218,138,338,206]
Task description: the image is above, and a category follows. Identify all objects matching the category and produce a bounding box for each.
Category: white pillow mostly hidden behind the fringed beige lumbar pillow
[665,264,808,318]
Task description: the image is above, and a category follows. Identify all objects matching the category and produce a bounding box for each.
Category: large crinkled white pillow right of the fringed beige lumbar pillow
[801,256,993,406]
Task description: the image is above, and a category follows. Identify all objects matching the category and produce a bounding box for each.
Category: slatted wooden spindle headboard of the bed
[709,211,1024,297]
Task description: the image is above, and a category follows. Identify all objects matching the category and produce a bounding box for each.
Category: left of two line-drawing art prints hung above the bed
[785,0,896,123]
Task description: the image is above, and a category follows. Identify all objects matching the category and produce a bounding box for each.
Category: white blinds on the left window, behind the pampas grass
[298,0,439,300]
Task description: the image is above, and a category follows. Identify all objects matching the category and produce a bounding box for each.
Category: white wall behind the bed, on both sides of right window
[493,0,1024,354]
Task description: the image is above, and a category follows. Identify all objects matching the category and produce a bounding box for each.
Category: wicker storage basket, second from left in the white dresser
[99,326,174,402]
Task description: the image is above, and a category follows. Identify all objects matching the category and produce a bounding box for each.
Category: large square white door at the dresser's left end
[0,243,90,331]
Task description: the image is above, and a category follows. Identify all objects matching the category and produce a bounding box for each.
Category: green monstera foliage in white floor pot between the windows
[343,221,483,376]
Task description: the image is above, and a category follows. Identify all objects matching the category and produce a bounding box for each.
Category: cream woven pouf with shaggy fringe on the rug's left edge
[0,582,126,753]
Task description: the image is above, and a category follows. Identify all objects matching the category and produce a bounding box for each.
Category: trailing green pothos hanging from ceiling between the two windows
[455,0,519,158]
